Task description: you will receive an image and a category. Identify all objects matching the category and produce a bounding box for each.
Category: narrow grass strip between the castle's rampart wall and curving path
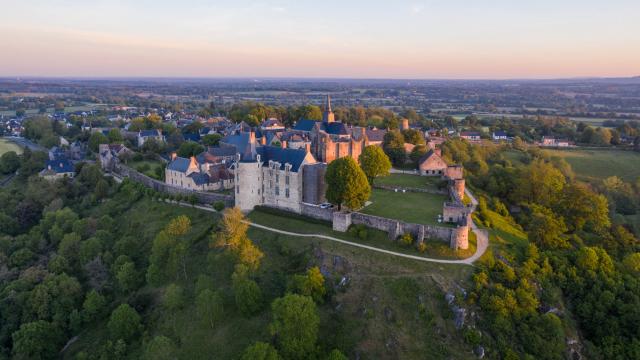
[249,210,476,260]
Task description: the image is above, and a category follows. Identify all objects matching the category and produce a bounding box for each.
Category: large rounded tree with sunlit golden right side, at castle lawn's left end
[325,156,371,209]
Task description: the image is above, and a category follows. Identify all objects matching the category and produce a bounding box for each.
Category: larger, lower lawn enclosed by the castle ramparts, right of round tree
[360,189,448,226]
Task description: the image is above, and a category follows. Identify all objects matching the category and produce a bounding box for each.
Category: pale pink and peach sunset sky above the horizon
[0,0,640,79]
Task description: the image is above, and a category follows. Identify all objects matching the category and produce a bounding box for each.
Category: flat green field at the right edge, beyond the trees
[545,149,640,182]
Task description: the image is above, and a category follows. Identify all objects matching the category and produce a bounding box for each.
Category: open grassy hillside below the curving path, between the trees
[63,200,474,359]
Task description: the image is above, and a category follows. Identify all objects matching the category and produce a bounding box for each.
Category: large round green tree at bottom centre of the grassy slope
[269,294,320,359]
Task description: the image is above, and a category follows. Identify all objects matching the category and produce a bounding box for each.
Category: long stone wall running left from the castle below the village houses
[113,164,234,207]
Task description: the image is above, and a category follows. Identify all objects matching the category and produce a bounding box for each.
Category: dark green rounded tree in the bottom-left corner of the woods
[11,320,63,360]
